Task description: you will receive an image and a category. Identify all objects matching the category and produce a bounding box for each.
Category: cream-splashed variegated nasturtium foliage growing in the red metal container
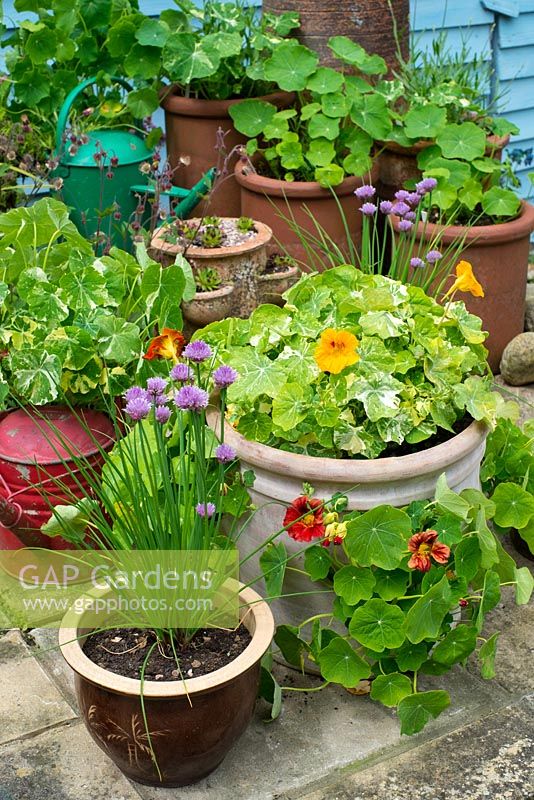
[0,198,185,407]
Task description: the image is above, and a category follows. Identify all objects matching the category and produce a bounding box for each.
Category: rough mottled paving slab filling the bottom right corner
[288,696,534,800]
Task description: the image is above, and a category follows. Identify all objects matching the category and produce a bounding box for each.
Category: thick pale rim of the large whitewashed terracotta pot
[208,409,489,486]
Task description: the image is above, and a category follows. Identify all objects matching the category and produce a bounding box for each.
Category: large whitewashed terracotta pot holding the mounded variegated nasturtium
[209,412,488,625]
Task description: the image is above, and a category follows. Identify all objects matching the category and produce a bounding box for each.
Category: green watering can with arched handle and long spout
[54,78,215,249]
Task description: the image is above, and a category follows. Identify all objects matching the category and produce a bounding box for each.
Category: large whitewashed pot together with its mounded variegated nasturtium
[203,265,516,628]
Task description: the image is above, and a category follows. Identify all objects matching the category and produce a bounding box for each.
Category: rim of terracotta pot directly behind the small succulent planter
[234,161,378,200]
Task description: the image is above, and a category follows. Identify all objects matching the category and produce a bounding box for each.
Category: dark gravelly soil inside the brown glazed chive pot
[82,625,252,681]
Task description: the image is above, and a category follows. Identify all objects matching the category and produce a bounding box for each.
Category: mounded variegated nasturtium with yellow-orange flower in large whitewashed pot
[202,265,510,460]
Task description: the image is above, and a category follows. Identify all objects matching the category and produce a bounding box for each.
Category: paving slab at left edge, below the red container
[0,631,75,748]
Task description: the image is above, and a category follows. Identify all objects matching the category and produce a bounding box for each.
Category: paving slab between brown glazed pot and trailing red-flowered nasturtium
[132,669,509,800]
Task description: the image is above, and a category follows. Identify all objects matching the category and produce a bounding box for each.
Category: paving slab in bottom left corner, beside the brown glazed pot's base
[0,722,144,800]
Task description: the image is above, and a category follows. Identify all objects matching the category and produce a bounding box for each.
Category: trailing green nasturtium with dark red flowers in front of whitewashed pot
[269,482,534,735]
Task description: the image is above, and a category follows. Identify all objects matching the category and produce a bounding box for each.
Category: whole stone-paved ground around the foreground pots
[0,386,534,800]
